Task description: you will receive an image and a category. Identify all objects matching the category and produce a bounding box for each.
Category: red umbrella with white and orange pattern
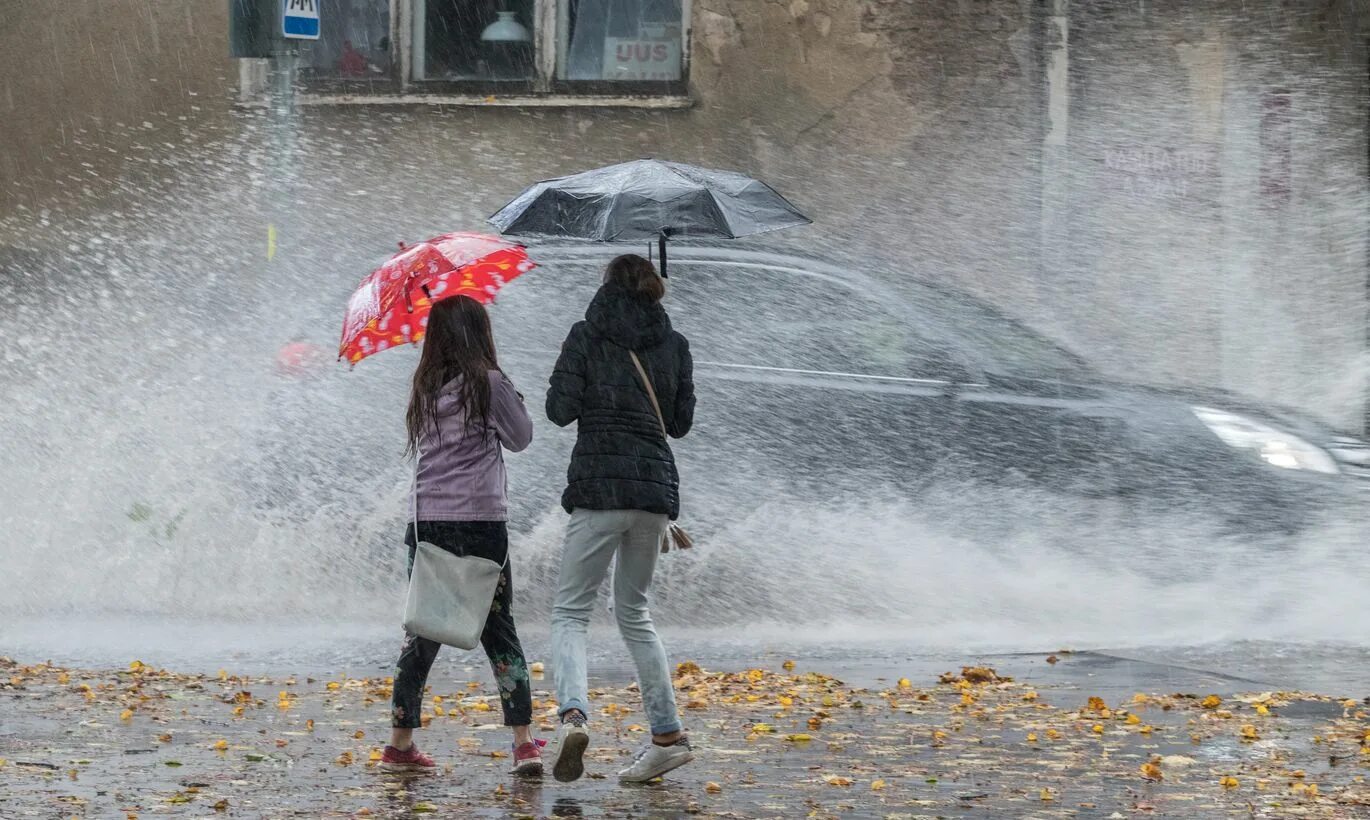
[338,233,536,364]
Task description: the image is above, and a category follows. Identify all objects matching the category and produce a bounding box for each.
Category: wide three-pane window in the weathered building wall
[258,0,690,101]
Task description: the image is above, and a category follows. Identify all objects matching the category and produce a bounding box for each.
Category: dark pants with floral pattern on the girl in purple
[390,522,533,728]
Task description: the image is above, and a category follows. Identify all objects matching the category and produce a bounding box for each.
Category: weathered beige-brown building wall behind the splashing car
[0,0,1366,426]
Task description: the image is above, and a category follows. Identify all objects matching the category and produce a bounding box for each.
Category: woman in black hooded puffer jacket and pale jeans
[547,255,695,782]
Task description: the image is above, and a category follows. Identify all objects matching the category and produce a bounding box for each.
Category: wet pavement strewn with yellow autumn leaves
[0,641,1370,817]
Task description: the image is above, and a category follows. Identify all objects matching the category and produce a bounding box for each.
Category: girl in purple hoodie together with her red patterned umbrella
[338,233,543,775]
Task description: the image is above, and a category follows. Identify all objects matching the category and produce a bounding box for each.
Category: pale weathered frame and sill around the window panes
[240,0,693,108]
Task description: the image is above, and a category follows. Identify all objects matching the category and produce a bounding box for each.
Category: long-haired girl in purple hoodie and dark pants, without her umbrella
[381,296,543,773]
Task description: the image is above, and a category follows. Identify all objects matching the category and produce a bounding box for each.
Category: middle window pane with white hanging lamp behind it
[412,0,534,82]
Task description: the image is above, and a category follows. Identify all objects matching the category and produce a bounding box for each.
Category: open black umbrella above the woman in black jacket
[490,159,811,277]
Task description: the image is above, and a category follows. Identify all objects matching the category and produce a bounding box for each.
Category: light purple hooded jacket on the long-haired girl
[415,370,533,522]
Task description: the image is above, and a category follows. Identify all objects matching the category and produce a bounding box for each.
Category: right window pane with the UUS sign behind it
[559,0,682,82]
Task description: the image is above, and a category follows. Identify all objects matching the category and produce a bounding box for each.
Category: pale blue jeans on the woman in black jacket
[552,509,681,735]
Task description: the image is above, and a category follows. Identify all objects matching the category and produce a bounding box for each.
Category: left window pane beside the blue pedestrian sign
[300,0,390,81]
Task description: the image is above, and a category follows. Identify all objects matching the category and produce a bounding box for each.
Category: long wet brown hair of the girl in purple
[404,296,500,456]
